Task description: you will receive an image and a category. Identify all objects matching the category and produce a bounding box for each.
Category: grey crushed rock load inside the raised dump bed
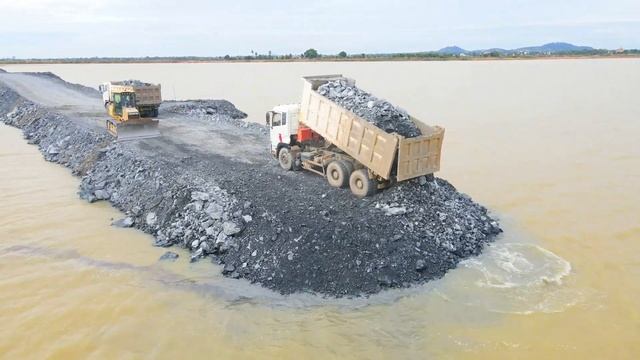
[318,80,422,138]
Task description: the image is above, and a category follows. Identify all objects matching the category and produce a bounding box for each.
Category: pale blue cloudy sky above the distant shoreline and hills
[0,0,640,58]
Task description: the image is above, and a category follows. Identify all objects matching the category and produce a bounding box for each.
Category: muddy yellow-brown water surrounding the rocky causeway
[0,60,640,359]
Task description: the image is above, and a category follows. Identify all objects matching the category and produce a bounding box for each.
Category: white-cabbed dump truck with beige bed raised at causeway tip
[266,75,444,197]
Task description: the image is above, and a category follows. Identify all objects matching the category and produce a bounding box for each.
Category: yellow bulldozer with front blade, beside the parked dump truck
[101,84,160,141]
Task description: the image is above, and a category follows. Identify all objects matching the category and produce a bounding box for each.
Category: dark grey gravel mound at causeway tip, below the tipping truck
[220,168,502,296]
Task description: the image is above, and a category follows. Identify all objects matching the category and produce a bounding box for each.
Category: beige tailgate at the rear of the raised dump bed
[397,126,444,181]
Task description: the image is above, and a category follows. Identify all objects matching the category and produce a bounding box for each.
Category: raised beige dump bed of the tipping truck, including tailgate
[300,75,444,181]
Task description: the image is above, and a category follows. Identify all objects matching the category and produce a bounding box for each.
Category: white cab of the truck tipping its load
[266,104,300,156]
